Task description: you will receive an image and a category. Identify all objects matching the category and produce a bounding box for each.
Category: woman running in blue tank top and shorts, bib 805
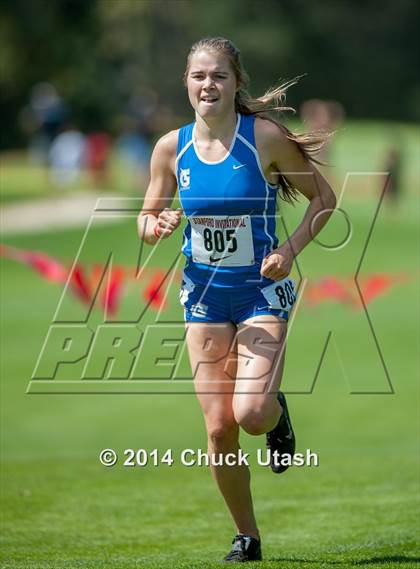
[138,38,336,562]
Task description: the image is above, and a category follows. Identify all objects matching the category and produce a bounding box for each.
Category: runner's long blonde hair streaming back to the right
[184,37,332,202]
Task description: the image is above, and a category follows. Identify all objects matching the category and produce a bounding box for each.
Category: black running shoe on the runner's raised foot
[266,391,296,474]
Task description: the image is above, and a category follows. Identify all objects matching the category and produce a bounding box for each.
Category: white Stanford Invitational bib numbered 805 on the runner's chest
[189,215,255,267]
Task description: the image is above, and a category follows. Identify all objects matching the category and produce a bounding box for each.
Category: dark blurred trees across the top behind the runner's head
[0,0,420,148]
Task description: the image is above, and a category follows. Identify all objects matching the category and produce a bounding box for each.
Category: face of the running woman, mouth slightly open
[187,51,237,118]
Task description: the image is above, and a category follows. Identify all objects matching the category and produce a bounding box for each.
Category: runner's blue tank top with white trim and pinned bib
[176,114,278,288]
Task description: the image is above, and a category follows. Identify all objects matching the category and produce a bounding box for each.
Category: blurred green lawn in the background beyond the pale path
[0,120,420,203]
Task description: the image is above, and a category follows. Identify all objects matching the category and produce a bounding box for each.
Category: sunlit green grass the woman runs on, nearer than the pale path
[1,122,420,569]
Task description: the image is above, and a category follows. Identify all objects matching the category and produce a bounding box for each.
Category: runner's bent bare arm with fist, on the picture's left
[137,130,182,245]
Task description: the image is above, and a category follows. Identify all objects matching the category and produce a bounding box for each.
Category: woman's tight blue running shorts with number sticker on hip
[179,272,296,324]
